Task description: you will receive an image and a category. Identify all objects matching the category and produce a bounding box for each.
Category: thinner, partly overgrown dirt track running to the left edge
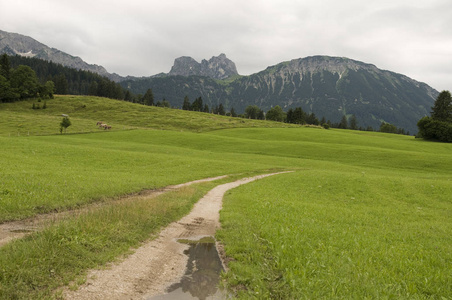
[0,176,226,247]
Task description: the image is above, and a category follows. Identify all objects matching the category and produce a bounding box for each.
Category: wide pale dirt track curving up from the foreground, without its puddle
[63,173,288,299]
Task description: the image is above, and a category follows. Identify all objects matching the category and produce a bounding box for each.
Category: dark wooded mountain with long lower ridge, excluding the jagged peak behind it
[121,56,438,133]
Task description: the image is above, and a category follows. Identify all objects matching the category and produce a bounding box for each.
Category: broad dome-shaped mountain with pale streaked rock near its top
[233,56,438,133]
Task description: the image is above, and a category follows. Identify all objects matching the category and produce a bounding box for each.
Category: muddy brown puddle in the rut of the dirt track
[148,237,227,300]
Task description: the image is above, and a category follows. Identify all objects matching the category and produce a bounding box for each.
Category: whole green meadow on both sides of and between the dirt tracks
[0,96,452,299]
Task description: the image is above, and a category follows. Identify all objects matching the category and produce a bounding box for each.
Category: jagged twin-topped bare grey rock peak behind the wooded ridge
[168,53,238,79]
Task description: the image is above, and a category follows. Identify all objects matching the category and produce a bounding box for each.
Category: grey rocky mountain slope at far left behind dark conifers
[0,30,123,82]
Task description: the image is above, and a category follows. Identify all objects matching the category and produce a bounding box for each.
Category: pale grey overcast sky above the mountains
[0,0,452,91]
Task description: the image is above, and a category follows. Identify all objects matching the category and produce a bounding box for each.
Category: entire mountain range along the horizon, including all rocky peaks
[0,31,439,133]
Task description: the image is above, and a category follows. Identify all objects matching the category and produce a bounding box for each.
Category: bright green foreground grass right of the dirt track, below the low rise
[218,169,452,299]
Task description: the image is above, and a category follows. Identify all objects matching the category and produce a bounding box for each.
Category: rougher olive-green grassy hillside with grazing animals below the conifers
[0,95,291,136]
